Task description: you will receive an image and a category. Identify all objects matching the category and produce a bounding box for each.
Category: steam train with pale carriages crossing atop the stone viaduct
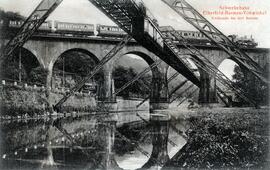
[0,20,258,48]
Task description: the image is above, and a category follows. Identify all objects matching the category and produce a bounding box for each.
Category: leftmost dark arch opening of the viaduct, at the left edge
[1,48,46,86]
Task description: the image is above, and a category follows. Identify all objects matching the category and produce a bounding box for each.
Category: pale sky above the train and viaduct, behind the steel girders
[0,0,270,78]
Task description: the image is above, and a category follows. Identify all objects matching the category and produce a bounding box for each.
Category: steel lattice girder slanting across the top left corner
[1,0,63,60]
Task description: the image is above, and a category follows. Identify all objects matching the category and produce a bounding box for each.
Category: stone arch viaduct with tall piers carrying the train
[1,33,269,107]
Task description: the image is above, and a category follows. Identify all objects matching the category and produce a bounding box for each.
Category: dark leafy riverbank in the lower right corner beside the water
[163,108,269,169]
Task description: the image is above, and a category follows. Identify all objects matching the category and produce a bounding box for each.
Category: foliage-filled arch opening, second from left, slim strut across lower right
[52,49,101,93]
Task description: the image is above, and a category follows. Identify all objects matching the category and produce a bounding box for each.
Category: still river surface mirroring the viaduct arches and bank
[0,115,186,169]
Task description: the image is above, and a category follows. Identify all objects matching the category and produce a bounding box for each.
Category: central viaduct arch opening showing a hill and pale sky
[113,52,158,98]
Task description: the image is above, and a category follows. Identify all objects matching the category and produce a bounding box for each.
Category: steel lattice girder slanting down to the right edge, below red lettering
[162,0,268,83]
